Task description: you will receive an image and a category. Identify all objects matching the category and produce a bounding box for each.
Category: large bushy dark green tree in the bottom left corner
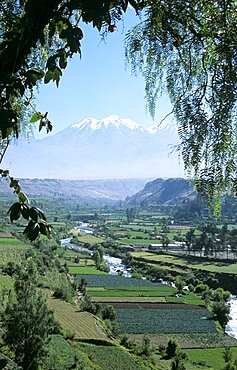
[2,260,56,370]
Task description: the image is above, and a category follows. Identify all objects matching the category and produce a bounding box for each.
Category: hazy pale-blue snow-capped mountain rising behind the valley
[3,115,183,179]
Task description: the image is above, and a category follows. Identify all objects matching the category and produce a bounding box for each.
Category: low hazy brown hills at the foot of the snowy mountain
[0,178,197,208]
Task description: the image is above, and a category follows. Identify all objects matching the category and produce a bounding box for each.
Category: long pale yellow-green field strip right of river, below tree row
[131,251,237,274]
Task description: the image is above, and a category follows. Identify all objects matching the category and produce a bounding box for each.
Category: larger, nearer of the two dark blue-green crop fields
[116,309,216,334]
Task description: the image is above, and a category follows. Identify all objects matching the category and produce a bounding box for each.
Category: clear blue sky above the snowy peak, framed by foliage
[36,9,171,137]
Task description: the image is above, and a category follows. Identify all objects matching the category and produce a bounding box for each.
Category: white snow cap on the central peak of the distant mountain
[71,114,142,131]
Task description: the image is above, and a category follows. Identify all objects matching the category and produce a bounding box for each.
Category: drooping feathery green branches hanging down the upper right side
[126,0,237,206]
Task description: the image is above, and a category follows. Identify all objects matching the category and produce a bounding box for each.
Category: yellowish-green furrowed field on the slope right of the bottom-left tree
[48,295,109,341]
